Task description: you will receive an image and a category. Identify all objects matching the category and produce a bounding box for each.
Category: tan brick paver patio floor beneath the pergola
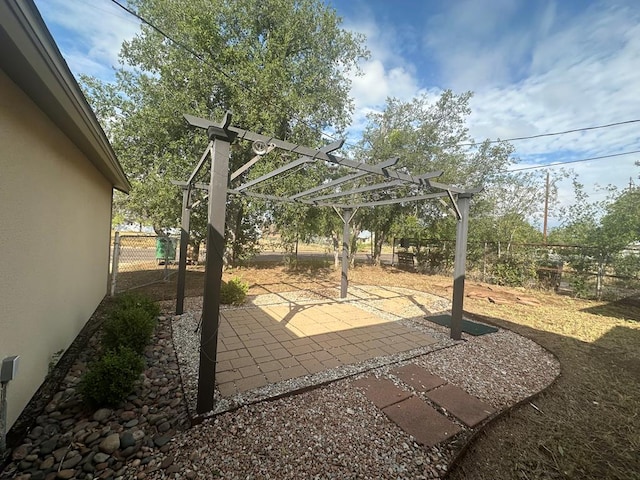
[216,300,435,397]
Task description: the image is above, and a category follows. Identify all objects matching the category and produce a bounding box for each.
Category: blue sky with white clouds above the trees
[36,0,640,221]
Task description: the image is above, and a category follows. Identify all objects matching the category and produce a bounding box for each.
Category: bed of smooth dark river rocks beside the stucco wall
[0,320,188,480]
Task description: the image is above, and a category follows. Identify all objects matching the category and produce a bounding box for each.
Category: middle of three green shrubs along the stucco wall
[102,305,156,354]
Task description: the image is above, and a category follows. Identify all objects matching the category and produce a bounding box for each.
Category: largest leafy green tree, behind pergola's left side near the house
[82,0,366,260]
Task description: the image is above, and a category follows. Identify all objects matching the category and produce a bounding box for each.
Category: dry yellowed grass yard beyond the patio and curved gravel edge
[131,262,640,479]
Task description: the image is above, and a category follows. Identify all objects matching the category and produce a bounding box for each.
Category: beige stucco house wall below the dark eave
[0,70,112,427]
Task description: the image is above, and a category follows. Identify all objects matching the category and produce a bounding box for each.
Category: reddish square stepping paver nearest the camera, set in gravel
[382,397,460,447]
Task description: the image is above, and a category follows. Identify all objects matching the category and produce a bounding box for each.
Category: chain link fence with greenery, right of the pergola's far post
[396,239,640,299]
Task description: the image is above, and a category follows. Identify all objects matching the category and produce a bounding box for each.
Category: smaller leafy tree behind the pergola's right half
[356,90,512,262]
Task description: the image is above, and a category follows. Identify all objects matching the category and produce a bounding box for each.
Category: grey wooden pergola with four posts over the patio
[174,112,480,414]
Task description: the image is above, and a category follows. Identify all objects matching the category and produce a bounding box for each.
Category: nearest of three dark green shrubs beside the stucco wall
[79,347,144,407]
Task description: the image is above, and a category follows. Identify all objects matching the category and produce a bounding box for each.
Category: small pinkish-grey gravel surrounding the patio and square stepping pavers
[149,289,560,479]
